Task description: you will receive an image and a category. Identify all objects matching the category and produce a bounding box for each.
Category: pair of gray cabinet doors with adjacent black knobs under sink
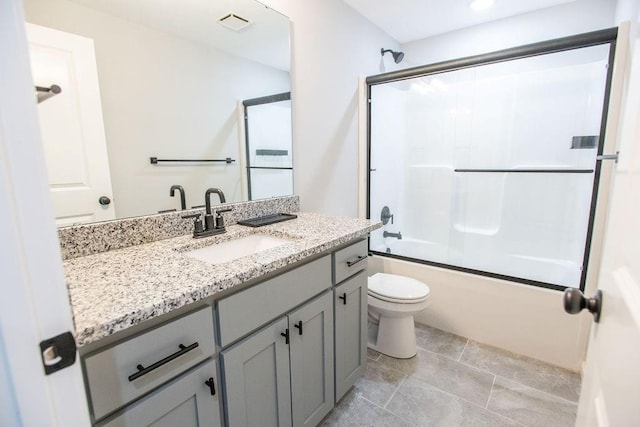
[221,292,334,427]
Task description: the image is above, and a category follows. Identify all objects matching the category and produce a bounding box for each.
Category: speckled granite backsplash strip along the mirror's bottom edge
[58,196,300,260]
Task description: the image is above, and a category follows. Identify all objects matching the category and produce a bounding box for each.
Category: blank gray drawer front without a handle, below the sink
[216,255,331,347]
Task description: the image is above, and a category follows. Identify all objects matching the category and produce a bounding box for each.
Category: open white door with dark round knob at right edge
[576,25,640,427]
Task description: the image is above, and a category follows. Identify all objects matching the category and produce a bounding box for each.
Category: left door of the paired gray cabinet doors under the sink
[221,317,291,427]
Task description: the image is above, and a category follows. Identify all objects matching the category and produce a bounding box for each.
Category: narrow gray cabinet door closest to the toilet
[334,270,367,402]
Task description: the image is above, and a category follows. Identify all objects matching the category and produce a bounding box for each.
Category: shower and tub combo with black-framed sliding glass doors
[366,28,617,370]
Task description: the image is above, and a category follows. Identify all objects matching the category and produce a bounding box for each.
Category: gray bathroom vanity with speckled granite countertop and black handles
[65,206,379,426]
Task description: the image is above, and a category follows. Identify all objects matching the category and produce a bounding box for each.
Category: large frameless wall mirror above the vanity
[23,0,293,225]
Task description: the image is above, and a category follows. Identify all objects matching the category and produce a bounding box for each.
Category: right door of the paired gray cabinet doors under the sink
[288,292,334,427]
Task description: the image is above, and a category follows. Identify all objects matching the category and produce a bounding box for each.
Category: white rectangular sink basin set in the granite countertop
[184,234,293,264]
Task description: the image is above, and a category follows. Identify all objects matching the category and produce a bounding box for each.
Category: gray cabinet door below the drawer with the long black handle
[100,360,221,427]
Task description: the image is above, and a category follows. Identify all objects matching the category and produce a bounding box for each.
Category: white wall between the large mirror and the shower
[265,0,398,216]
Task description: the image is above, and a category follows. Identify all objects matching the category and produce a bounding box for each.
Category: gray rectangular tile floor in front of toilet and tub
[321,324,580,427]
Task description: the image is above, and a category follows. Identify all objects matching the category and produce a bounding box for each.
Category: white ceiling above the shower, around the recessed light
[343,0,577,43]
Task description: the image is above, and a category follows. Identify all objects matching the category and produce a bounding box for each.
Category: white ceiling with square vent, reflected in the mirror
[73,0,291,71]
